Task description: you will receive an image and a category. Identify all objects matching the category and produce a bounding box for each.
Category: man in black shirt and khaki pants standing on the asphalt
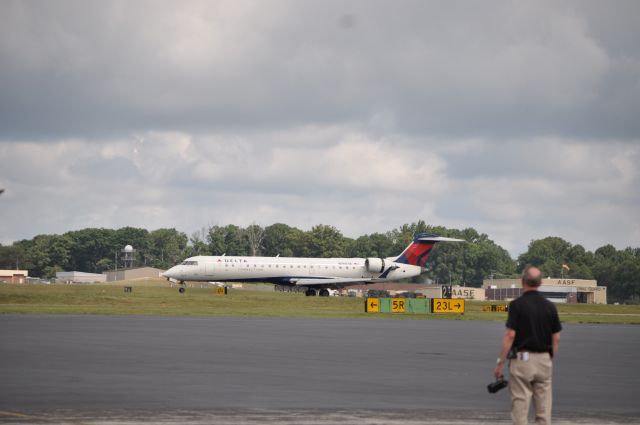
[494,266,562,425]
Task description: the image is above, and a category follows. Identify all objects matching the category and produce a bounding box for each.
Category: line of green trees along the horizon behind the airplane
[0,221,640,302]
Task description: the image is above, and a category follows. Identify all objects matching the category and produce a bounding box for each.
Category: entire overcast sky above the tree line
[0,0,640,256]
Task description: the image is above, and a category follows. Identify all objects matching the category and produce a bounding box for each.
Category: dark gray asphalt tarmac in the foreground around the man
[0,315,640,423]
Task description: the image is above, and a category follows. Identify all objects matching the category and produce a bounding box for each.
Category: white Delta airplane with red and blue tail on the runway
[162,233,464,297]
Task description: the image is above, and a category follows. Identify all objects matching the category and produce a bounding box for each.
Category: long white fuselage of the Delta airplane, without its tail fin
[163,255,422,286]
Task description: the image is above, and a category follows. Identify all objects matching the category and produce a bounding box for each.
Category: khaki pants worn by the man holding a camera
[509,353,553,425]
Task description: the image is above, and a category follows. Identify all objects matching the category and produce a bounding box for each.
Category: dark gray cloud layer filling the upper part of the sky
[0,1,640,139]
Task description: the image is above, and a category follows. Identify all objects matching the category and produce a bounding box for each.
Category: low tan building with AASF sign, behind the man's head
[482,278,607,304]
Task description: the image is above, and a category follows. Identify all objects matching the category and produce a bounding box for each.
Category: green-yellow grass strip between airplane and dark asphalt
[0,281,640,324]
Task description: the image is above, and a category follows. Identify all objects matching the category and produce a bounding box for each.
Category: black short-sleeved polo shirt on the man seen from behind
[507,291,562,355]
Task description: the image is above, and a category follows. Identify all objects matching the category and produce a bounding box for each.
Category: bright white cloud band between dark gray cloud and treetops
[0,132,640,254]
